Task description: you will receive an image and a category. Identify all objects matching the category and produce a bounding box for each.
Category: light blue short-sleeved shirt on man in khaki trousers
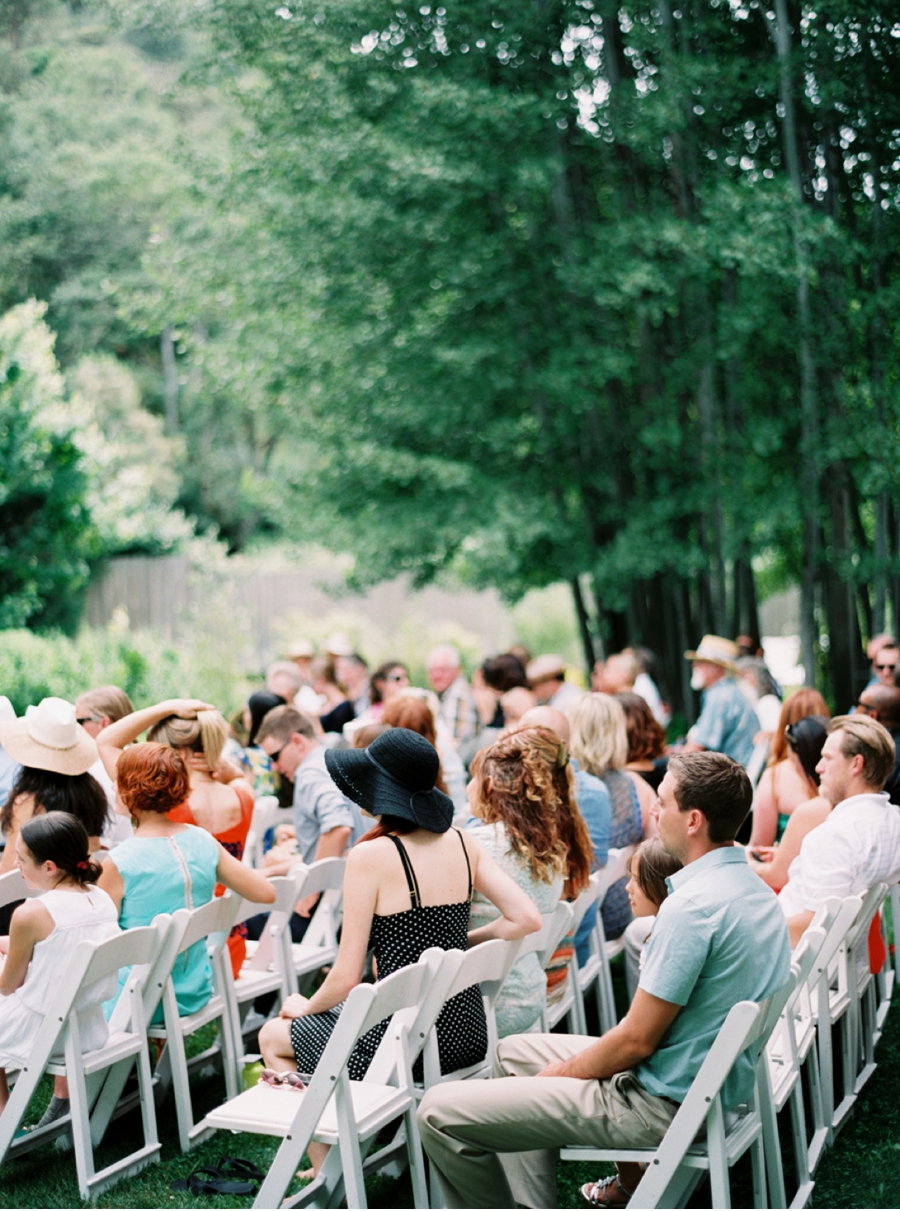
[635,845,791,1109]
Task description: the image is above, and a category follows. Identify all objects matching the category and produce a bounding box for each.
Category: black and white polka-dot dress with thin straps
[291,830,487,1080]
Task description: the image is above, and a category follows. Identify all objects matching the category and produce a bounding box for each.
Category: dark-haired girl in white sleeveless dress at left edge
[0,811,120,1121]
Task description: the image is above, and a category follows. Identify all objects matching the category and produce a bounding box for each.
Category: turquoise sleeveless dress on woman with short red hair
[104,825,219,1022]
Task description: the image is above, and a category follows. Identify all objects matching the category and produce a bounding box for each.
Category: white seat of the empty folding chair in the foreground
[205,1080,409,1144]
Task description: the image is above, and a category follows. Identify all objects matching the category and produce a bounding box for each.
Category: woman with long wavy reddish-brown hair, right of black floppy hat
[469,728,592,1037]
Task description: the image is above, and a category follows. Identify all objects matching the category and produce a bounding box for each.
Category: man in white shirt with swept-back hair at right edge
[778,714,900,946]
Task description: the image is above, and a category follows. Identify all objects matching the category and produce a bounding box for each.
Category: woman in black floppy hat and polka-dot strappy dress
[259,728,541,1171]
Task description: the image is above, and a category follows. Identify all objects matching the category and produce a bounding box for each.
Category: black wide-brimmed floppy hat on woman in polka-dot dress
[325,728,453,833]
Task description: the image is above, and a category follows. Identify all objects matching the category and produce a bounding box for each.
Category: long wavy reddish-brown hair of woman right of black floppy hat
[471,728,594,900]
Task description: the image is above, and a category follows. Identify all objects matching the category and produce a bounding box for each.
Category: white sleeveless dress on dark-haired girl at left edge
[0,886,120,1068]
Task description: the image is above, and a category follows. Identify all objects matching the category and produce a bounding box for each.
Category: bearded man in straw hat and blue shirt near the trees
[684,635,759,765]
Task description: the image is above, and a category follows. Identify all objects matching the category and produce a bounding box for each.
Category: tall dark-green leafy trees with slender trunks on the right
[197,0,900,701]
